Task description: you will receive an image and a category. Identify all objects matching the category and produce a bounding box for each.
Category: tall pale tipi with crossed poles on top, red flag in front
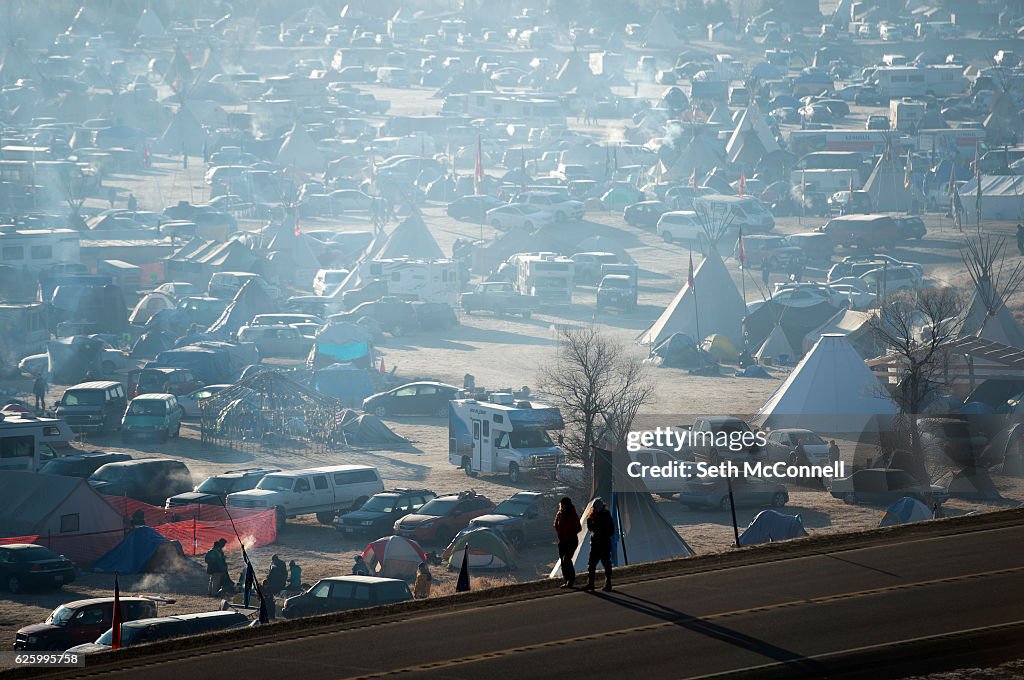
[637,248,746,346]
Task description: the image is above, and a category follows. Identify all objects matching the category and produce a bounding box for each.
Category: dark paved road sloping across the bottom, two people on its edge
[41,525,1024,680]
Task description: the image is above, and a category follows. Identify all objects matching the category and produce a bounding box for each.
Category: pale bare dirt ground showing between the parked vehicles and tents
[0,79,1024,639]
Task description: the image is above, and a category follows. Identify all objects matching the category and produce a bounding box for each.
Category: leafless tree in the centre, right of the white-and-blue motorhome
[540,327,653,486]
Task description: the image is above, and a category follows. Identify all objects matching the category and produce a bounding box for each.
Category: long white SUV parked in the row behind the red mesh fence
[227,465,384,530]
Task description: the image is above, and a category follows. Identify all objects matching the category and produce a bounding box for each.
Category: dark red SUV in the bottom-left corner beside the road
[14,597,161,651]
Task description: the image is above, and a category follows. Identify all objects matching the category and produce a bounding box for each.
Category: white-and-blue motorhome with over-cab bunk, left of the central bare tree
[449,393,565,483]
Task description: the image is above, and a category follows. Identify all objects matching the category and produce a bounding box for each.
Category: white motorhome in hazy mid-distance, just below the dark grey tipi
[355,257,460,307]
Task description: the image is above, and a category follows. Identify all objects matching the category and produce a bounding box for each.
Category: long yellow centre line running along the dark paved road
[346,566,1024,680]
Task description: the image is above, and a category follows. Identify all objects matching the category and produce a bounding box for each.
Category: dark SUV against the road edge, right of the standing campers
[281,576,413,619]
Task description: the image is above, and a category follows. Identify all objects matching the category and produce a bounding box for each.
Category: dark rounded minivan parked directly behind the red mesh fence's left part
[89,458,193,506]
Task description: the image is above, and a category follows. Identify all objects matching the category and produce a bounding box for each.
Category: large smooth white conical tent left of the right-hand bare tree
[755,334,898,434]
